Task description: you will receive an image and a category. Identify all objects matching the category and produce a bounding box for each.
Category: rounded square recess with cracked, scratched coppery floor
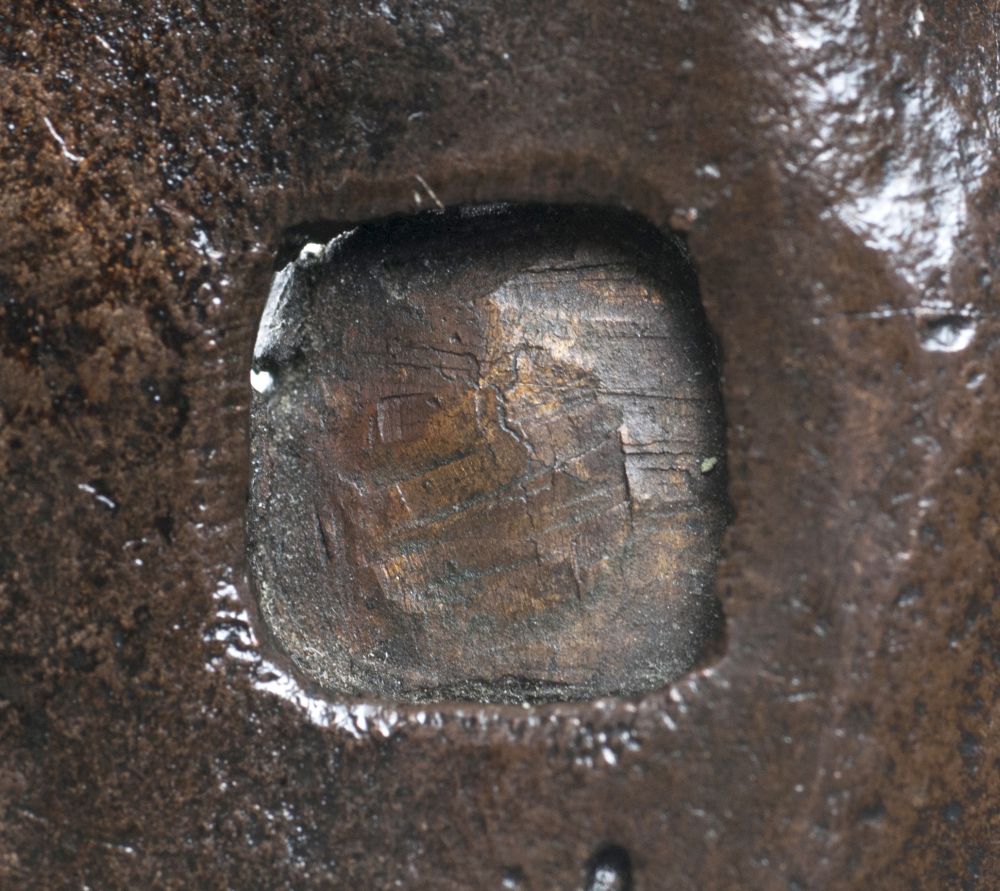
[248,208,727,702]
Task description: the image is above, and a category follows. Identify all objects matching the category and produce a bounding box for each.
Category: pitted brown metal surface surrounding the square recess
[0,0,1000,891]
